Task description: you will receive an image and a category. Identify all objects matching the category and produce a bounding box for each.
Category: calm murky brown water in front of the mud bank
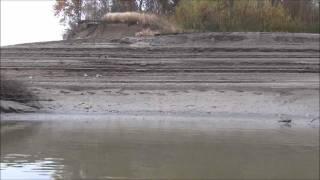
[1,118,319,179]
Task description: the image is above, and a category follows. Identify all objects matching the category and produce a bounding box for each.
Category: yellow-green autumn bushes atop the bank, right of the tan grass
[173,0,319,32]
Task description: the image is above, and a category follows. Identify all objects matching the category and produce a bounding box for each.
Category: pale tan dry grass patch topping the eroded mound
[102,12,179,36]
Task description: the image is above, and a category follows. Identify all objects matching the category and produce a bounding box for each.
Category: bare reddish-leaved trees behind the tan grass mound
[54,0,180,27]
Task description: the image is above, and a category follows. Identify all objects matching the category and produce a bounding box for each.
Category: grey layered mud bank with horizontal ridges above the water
[1,33,320,125]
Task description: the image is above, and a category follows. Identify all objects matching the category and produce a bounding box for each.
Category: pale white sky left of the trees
[0,0,64,46]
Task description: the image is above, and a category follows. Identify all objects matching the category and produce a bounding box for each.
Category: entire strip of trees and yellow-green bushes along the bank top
[54,0,320,33]
